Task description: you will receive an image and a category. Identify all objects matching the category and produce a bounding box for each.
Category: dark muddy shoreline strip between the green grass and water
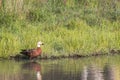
[0,49,120,60]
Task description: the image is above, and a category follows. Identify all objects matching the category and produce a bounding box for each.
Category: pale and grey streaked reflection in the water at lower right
[81,64,116,80]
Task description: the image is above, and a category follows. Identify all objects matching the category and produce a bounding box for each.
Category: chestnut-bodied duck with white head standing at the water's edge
[20,41,43,59]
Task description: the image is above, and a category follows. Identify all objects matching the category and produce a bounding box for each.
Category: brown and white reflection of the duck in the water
[22,62,42,80]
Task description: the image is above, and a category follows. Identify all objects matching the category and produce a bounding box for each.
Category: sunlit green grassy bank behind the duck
[0,0,120,58]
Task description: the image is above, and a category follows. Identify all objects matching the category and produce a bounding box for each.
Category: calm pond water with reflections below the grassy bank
[0,56,120,80]
